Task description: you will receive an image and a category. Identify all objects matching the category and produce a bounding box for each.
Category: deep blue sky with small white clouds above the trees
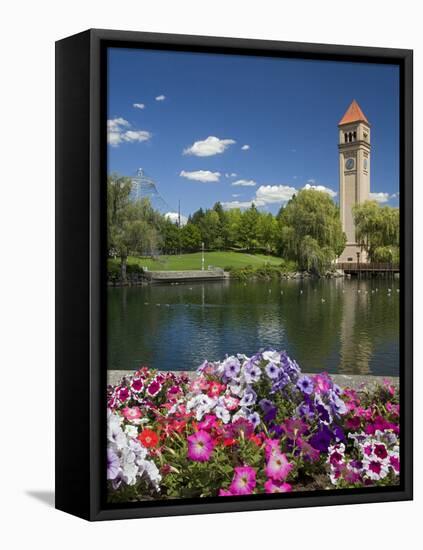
[108,48,399,220]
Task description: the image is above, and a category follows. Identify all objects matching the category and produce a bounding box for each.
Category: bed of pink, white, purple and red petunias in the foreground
[107,351,400,502]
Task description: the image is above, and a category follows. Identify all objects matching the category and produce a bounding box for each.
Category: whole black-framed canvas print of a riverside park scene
[56,30,412,520]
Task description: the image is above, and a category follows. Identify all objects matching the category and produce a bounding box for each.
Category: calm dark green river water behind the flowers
[107,279,400,376]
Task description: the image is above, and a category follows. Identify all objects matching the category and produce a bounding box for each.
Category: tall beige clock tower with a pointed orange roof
[338,100,370,262]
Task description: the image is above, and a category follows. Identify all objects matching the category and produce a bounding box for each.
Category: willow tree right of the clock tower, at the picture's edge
[353,201,400,262]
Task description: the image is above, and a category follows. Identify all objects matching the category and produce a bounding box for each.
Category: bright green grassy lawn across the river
[109,251,282,271]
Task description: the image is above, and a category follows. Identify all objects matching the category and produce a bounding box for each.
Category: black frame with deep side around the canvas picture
[55,29,413,521]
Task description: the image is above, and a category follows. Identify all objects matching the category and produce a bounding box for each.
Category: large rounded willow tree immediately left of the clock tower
[278,189,346,274]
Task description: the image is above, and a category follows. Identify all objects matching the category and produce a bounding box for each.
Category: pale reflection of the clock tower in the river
[338,280,372,374]
